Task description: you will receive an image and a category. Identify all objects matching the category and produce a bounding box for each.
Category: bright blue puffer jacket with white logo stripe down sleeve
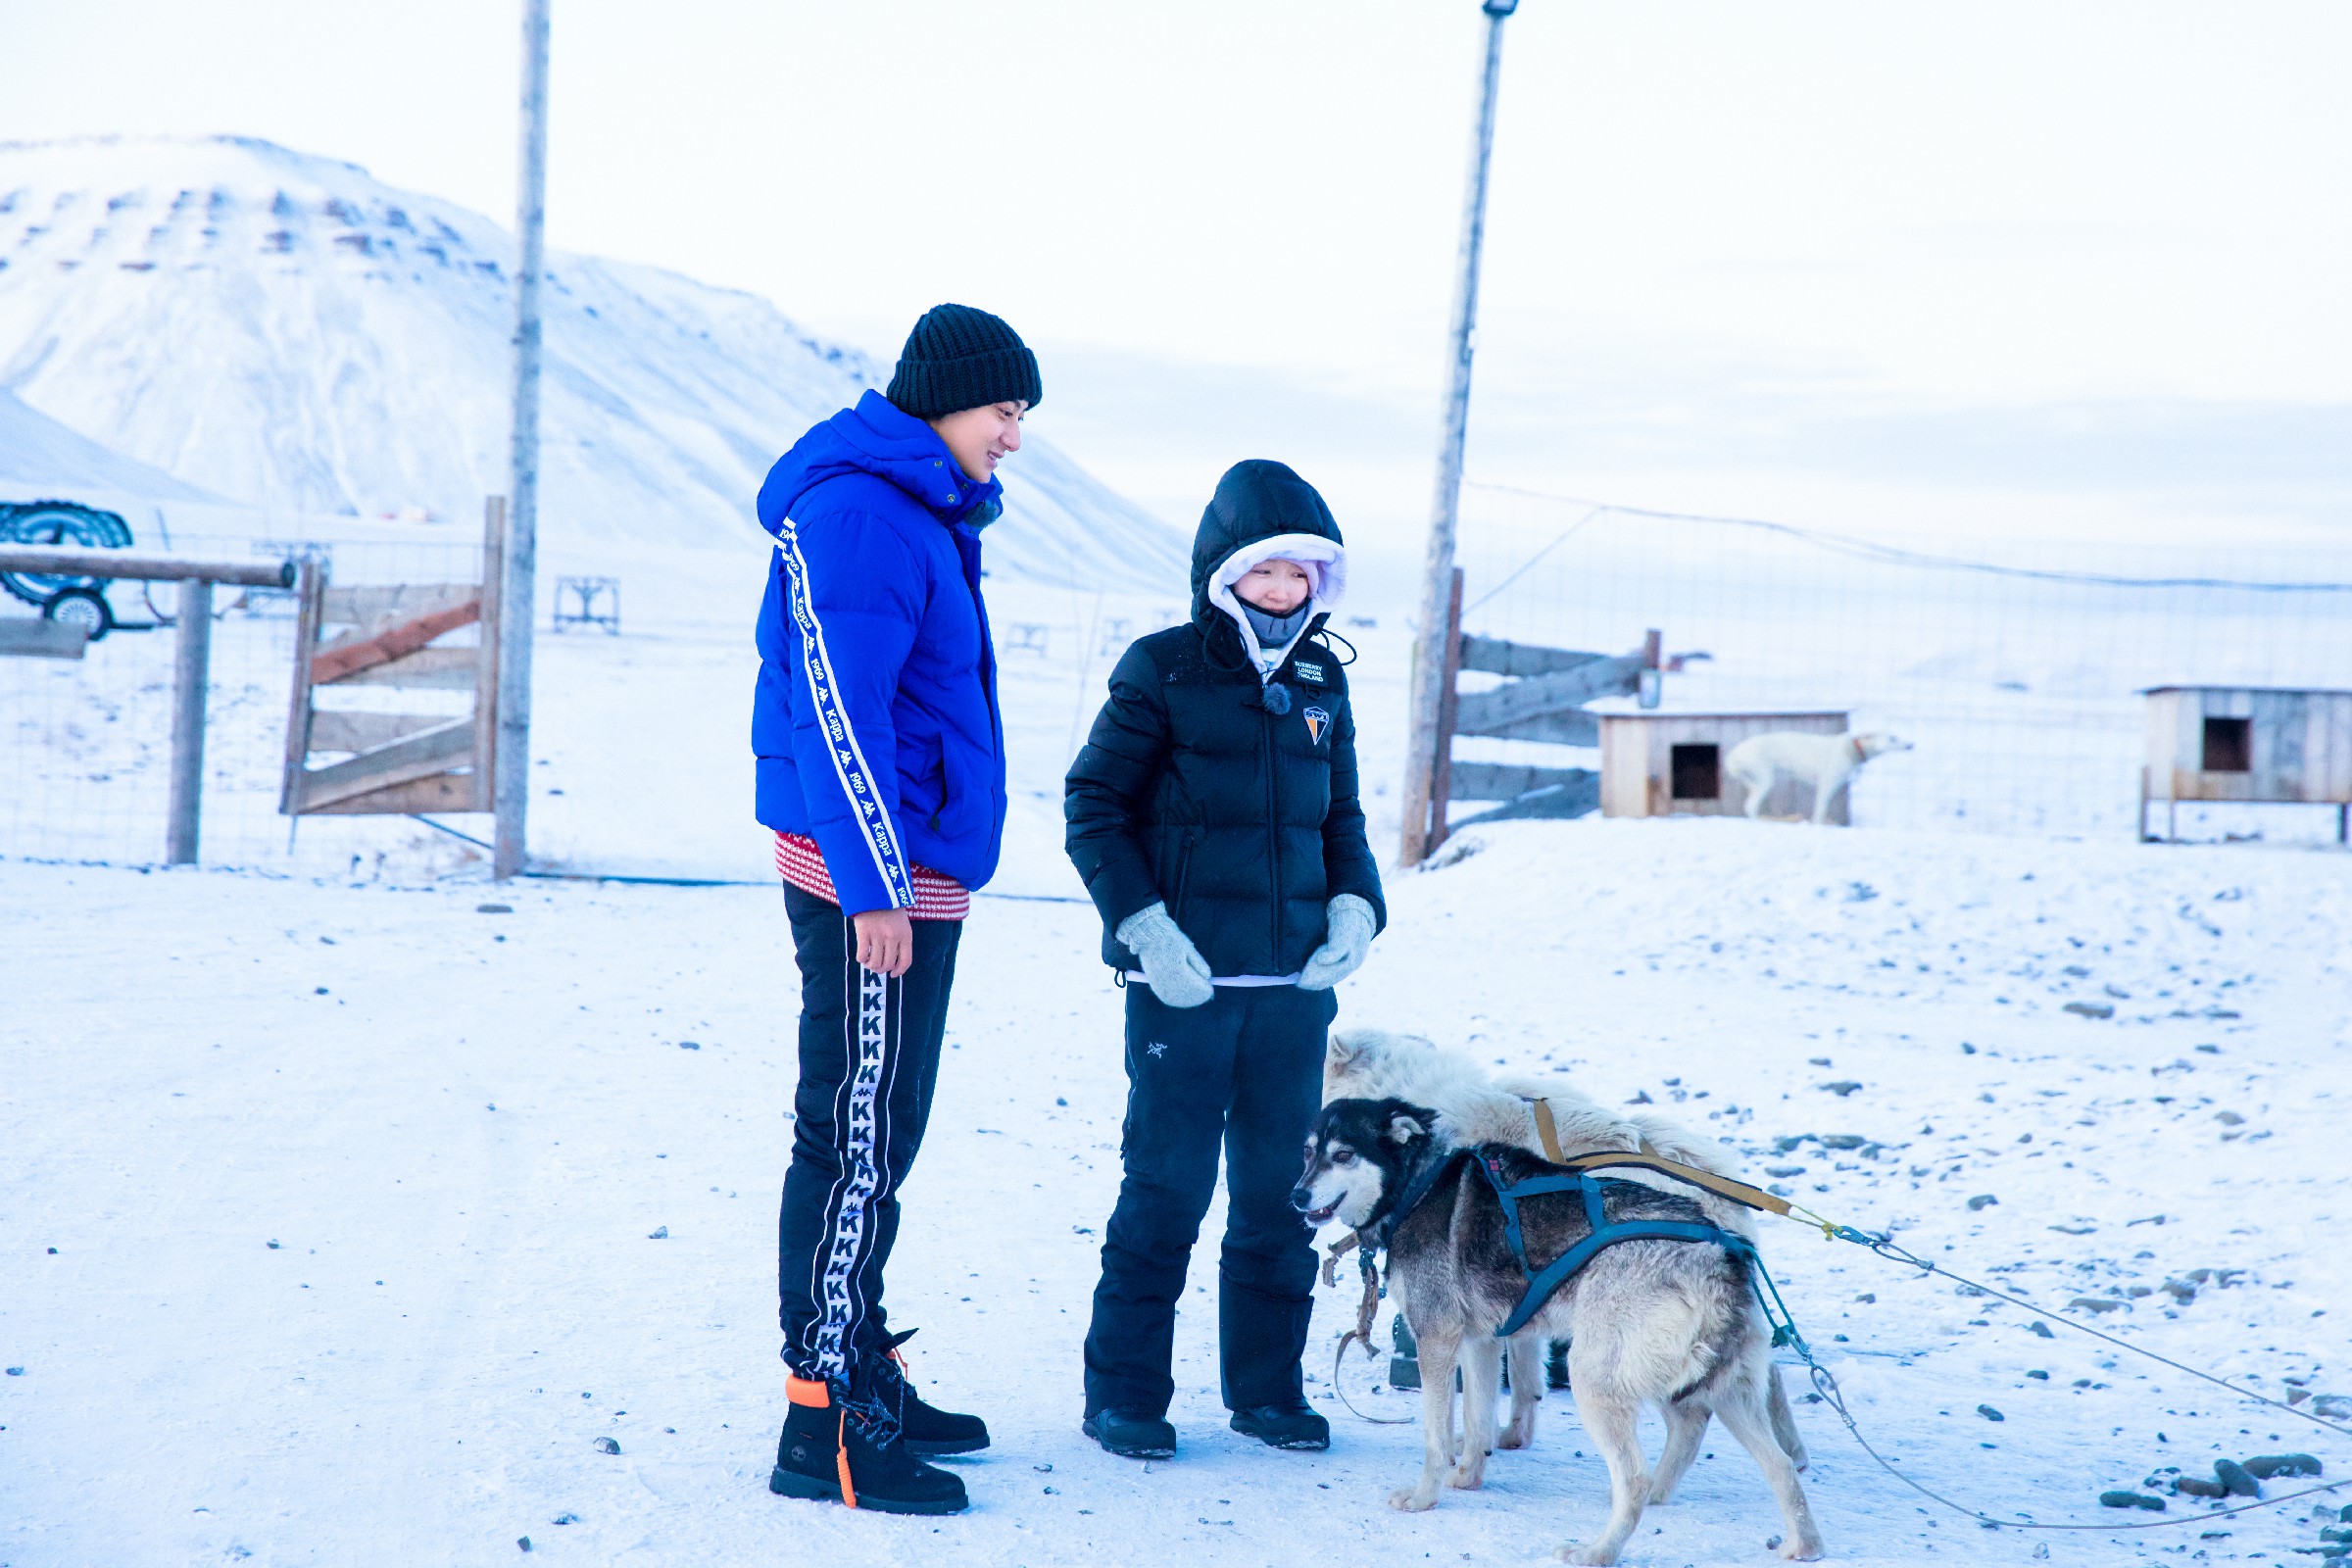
[751,393,1004,914]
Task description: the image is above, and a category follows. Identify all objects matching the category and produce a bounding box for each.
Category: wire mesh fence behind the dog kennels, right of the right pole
[1453,487,2352,842]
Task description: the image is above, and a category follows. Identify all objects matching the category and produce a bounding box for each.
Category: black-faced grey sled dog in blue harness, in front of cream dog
[1292,1098,1821,1563]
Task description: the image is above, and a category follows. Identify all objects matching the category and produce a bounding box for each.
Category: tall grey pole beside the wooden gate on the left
[492,0,548,882]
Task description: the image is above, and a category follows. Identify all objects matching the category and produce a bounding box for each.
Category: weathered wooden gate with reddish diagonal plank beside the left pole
[277,496,506,818]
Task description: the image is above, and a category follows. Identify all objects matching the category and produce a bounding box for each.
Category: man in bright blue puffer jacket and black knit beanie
[753,306,1042,1514]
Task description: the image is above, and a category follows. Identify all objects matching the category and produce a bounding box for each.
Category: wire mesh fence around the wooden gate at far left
[0,534,482,874]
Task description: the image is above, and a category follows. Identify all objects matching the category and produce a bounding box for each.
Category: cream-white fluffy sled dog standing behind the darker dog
[1324,1030,1811,1476]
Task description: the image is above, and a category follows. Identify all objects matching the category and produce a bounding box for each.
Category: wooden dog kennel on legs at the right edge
[2140,686,2352,844]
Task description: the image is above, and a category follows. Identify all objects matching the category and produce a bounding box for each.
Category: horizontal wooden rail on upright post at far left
[0,535,294,865]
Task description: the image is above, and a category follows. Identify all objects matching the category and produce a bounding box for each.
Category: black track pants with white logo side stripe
[776,884,964,1382]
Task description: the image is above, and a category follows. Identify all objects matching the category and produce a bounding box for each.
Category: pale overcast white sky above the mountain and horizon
[0,0,2352,536]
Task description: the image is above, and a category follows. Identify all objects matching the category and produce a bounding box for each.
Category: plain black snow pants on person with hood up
[1087,980,1339,1415]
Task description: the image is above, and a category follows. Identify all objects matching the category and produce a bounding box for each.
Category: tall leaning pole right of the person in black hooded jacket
[1397,0,1519,865]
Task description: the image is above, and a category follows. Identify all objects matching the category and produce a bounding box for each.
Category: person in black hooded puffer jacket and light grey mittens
[1063,461,1386,1457]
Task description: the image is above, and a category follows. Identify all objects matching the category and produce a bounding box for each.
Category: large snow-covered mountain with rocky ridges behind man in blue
[0,136,1186,588]
